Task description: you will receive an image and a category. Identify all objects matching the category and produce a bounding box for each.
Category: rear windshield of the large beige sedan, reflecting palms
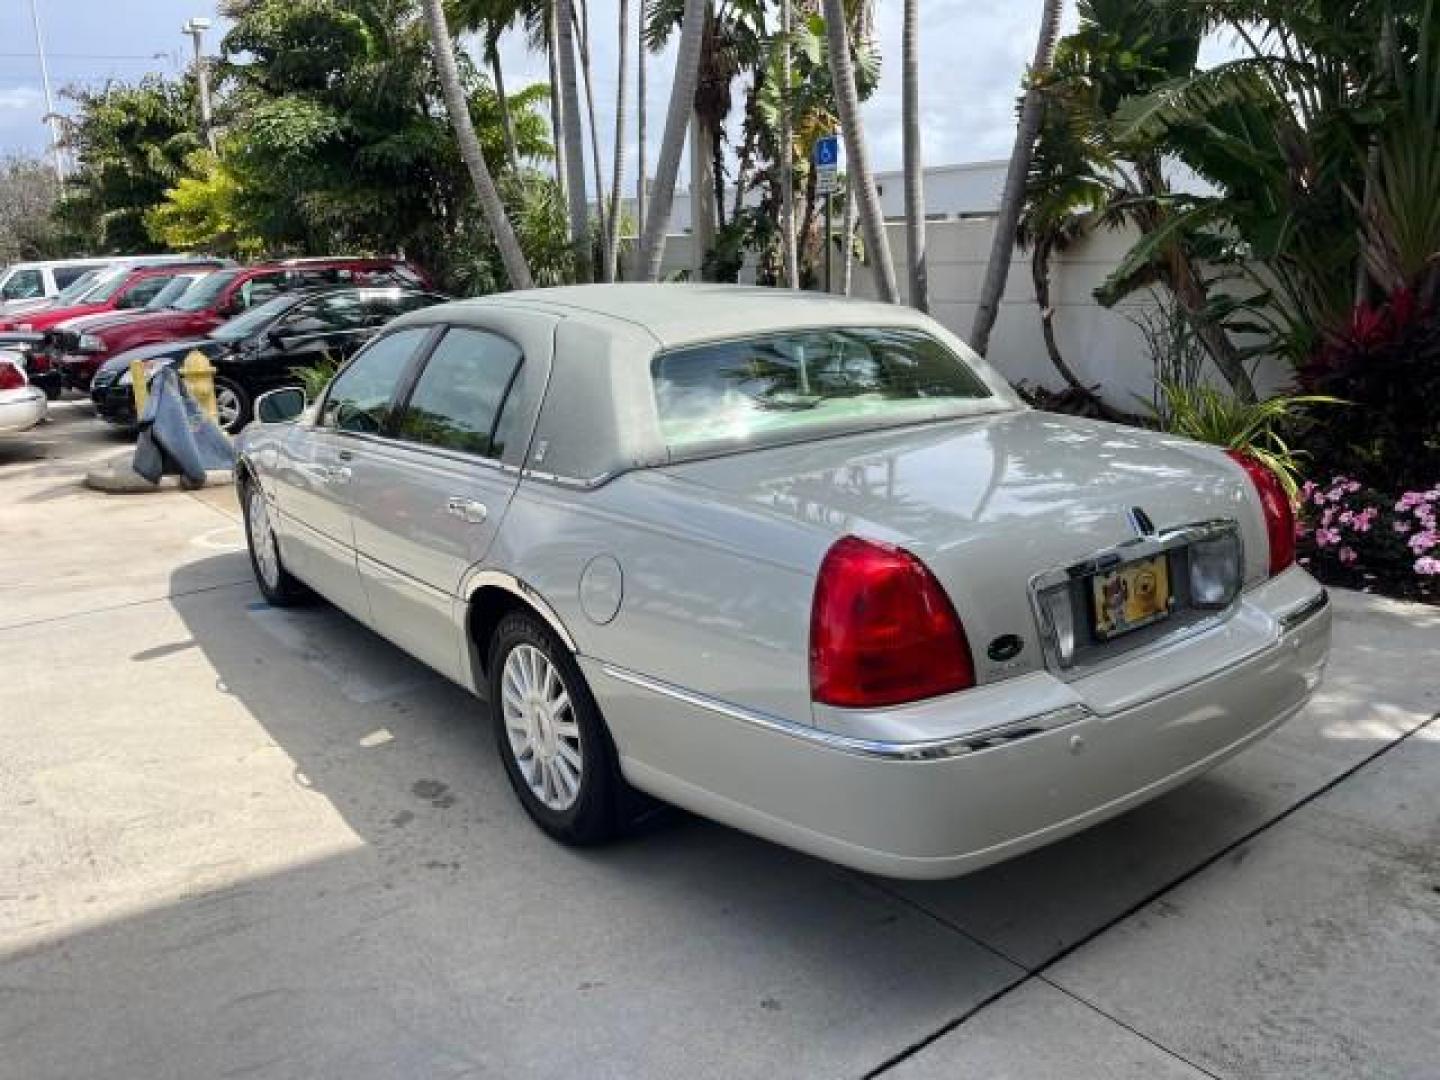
[651,327,991,452]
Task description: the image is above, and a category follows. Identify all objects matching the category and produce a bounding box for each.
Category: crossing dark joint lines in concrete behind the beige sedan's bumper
[863,713,1440,1080]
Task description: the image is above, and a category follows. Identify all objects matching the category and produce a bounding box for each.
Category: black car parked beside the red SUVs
[91,287,448,435]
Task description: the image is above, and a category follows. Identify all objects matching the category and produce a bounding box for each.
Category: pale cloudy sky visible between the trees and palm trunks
[0,0,1238,186]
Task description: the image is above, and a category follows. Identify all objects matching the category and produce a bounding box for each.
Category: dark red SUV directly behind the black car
[46,258,429,389]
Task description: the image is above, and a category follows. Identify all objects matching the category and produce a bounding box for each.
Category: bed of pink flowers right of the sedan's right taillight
[1296,477,1440,603]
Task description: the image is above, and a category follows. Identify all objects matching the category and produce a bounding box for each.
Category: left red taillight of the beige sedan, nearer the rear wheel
[811,536,975,708]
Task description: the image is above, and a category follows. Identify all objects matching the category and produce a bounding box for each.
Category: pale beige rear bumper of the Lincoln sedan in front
[582,570,1331,878]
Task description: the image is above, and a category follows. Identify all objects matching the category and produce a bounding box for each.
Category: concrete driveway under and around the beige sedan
[8,403,1440,1080]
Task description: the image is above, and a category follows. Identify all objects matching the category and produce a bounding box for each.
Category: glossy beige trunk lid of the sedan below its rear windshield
[664,410,1266,683]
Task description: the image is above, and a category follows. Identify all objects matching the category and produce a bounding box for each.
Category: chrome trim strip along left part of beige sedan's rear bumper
[600,664,1094,762]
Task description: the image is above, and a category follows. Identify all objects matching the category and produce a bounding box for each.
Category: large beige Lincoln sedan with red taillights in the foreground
[236,285,1331,877]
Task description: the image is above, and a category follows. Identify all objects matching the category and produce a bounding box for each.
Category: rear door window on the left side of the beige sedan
[399,330,521,458]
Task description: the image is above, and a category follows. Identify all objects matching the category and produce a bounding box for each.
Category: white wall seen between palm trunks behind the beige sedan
[664,219,1287,410]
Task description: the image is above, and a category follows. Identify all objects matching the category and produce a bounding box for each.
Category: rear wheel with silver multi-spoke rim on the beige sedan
[488,612,624,845]
